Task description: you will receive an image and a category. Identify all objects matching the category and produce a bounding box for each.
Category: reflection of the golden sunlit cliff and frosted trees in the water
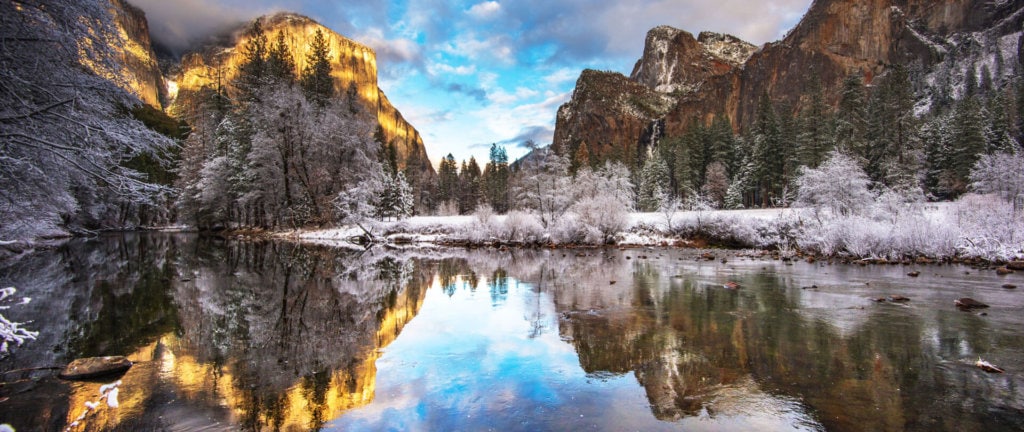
[146,243,426,430]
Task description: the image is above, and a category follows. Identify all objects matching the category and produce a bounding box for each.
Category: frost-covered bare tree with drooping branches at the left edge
[0,0,174,237]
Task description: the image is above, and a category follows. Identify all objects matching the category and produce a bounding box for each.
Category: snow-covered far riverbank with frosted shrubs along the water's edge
[280,197,1024,261]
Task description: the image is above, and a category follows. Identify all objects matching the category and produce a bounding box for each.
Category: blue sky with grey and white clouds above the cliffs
[130,0,811,166]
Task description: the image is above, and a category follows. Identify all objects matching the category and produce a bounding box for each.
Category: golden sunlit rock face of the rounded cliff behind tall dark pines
[169,13,433,177]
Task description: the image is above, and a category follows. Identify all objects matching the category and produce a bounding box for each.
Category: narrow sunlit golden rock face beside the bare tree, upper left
[111,0,165,109]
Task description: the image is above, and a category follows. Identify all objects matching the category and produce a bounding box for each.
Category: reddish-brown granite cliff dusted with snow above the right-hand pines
[553,0,1024,165]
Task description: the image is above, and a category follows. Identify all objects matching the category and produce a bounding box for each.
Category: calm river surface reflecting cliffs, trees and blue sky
[0,234,1024,431]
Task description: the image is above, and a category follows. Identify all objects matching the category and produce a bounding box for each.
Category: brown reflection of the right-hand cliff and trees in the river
[430,250,1024,431]
